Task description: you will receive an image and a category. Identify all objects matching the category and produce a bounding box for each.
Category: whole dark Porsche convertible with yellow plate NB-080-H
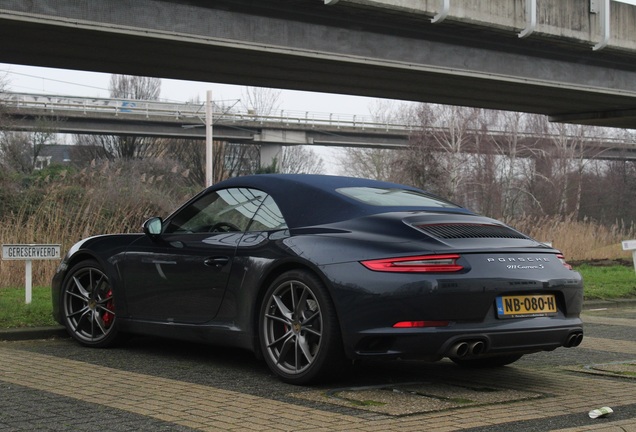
[52,175,583,384]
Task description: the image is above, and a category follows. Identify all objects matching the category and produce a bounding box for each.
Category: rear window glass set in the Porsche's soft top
[336,187,460,208]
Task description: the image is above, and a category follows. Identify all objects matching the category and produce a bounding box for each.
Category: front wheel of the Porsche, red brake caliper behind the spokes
[60,260,119,348]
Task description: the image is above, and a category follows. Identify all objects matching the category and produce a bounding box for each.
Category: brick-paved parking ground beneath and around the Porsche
[0,302,636,432]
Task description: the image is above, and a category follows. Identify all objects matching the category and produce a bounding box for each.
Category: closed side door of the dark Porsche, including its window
[120,188,267,323]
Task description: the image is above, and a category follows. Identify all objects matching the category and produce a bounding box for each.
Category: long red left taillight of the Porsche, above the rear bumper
[361,254,464,273]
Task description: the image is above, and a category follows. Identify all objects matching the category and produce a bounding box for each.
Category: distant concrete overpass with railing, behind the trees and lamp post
[0,93,636,166]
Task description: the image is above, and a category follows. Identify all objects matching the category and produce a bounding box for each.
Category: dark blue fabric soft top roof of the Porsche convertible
[208,174,471,228]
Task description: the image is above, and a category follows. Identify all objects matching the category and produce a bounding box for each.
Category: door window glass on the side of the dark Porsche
[165,188,267,233]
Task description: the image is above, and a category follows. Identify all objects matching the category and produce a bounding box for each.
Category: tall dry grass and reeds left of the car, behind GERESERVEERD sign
[0,159,192,287]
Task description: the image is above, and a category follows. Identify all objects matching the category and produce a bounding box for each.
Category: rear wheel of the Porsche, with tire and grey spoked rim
[259,270,344,385]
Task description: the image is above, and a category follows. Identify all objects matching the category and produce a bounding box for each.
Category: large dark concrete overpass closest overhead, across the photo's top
[0,0,636,128]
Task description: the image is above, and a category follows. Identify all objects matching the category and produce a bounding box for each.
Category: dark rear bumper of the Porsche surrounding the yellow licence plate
[324,254,583,360]
